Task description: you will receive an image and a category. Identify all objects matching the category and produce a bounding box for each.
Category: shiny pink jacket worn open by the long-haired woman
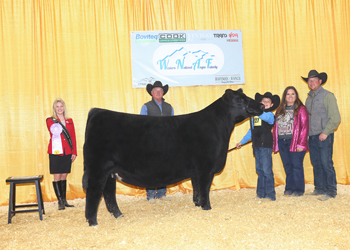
[272,106,309,153]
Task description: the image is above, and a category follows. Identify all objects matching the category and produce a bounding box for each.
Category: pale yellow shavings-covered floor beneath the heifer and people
[0,185,350,250]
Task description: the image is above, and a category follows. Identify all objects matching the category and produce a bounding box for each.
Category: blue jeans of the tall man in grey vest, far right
[309,133,337,198]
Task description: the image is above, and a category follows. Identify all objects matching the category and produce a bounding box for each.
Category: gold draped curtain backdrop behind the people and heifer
[0,0,350,205]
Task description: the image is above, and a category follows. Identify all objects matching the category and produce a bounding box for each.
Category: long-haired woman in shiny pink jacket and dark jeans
[273,86,309,196]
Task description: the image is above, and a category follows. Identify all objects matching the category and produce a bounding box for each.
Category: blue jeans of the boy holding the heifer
[254,147,276,201]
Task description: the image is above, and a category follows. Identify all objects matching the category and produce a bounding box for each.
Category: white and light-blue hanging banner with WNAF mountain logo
[131,30,245,88]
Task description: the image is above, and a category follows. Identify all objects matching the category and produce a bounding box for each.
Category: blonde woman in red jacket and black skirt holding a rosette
[46,98,77,210]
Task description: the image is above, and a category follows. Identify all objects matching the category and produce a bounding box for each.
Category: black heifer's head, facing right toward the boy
[222,89,264,119]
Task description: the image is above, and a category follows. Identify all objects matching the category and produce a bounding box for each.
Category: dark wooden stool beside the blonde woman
[6,175,45,224]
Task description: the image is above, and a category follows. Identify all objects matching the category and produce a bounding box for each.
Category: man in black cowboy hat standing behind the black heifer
[140,81,174,204]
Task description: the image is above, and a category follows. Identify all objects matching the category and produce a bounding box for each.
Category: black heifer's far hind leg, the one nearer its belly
[103,174,123,218]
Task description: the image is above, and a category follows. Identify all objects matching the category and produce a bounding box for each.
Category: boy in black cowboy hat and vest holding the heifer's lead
[236,92,280,201]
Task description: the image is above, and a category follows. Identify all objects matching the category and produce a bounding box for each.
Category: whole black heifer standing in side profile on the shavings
[83,89,263,226]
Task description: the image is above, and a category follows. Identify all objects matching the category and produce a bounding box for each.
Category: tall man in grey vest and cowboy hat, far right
[302,70,340,201]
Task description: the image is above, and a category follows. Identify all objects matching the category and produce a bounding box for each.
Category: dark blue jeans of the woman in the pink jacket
[278,139,306,196]
